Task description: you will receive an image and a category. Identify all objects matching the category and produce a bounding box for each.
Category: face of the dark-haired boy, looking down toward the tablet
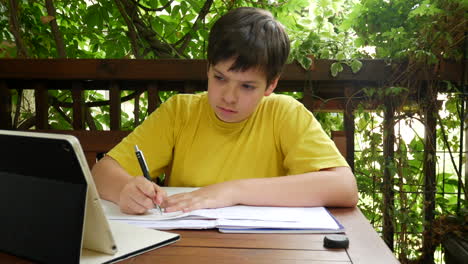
[208,59,278,123]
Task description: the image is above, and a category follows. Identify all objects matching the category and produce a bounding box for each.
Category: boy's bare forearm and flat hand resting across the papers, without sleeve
[163,167,358,212]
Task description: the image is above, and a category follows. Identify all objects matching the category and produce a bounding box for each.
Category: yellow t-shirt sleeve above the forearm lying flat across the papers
[279,100,349,175]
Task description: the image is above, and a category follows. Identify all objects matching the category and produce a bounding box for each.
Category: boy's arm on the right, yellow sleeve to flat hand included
[162,97,358,212]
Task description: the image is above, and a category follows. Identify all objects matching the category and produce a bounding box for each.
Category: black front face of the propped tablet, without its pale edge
[0,135,87,263]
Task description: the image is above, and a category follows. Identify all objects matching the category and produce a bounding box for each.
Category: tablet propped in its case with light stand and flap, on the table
[0,130,180,264]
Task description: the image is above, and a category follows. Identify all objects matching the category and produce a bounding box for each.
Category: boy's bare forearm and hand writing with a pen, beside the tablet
[91,156,167,214]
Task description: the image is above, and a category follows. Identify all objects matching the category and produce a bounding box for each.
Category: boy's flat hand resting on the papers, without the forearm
[162,181,237,213]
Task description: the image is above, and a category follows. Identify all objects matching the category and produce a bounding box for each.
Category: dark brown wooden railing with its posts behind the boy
[0,59,466,254]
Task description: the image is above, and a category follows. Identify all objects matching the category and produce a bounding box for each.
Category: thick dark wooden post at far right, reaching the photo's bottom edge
[422,83,438,263]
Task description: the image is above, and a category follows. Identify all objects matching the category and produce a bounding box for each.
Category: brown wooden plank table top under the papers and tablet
[0,208,398,264]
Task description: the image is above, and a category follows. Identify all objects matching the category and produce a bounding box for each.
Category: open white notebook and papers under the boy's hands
[102,188,344,233]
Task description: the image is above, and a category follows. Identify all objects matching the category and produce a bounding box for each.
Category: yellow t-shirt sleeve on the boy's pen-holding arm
[107,97,176,178]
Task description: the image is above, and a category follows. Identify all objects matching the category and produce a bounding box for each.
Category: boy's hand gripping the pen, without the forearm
[119,176,167,214]
